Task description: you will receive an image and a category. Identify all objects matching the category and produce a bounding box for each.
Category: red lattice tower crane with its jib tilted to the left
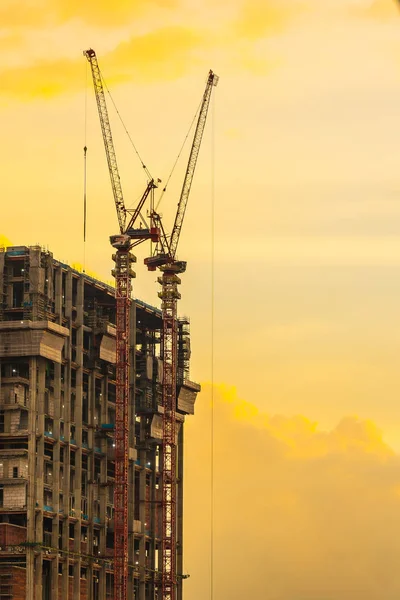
[84,48,159,600]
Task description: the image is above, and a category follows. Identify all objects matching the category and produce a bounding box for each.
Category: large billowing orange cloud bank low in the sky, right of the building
[185,386,400,600]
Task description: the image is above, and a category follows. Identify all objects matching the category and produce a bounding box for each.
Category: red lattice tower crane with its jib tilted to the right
[144,71,219,600]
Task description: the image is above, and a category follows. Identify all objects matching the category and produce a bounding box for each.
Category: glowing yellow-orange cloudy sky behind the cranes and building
[0,0,400,600]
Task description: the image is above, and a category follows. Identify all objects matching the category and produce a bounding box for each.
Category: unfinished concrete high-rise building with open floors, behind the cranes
[0,246,200,600]
